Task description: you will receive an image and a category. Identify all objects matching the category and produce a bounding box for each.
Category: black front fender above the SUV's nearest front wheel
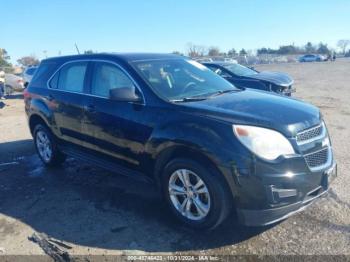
[145,117,241,199]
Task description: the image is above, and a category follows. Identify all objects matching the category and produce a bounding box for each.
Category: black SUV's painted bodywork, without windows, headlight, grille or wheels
[25,54,334,225]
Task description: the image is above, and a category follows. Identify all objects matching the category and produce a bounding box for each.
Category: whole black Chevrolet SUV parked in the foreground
[24,54,336,228]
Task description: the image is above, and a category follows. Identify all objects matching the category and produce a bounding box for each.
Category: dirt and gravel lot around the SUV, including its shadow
[0,60,350,260]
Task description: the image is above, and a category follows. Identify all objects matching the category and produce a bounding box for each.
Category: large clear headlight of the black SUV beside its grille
[233,125,295,160]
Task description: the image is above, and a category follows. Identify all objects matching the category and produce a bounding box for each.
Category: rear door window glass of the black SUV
[50,62,88,93]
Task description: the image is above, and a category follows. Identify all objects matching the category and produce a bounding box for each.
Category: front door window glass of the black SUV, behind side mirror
[91,63,134,97]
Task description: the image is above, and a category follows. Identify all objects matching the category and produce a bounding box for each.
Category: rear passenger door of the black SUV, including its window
[48,61,89,145]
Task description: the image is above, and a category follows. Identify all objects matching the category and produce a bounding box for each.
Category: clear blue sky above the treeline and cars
[0,0,350,62]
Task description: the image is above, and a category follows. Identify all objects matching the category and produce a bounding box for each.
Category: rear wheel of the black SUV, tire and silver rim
[33,124,66,167]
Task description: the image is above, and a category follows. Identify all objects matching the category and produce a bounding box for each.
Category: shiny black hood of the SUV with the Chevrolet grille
[181,89,321,137]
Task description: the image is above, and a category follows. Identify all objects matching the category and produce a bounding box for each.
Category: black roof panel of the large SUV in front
[43,53,182,62]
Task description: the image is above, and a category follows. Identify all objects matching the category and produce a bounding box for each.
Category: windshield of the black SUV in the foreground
[132,59,238,100]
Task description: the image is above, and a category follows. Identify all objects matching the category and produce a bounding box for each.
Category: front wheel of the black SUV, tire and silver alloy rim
[162,158,232,229]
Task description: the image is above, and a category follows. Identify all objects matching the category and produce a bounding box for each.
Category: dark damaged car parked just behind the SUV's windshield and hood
[203,62,295,96]
